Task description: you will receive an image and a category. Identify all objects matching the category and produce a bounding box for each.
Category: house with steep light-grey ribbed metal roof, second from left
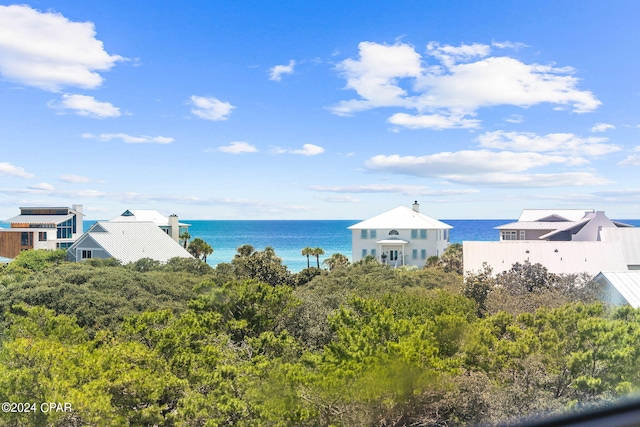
[68,220,193,264]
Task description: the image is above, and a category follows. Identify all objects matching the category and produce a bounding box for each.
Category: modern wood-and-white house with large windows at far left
[0,205,83,258]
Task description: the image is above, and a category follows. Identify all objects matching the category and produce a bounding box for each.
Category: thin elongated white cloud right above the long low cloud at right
[478,131,621,157]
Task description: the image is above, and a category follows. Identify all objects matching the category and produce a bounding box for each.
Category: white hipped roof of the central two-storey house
[348,206,453,230]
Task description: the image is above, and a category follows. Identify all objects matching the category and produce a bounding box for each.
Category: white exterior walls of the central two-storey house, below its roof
[351,229,450,267]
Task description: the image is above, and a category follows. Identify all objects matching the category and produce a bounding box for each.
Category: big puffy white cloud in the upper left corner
[0,5,124,92]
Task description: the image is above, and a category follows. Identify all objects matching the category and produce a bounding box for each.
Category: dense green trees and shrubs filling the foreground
[0,245,640,426]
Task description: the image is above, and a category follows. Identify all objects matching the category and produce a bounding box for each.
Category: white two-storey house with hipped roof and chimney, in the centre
[349,202,453,267]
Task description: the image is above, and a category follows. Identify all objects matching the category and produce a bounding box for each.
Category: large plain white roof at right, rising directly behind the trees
[462,240,627,275]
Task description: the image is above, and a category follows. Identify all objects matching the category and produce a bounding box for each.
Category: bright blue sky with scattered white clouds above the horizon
[0,0,640,219]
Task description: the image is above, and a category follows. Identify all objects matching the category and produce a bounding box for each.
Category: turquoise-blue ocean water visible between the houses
[84,219,640,272]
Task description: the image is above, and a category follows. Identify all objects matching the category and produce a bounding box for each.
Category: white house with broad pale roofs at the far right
[462,209,640,275]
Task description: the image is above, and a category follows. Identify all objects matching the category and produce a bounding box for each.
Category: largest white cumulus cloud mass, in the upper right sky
[330,42,601,129]
